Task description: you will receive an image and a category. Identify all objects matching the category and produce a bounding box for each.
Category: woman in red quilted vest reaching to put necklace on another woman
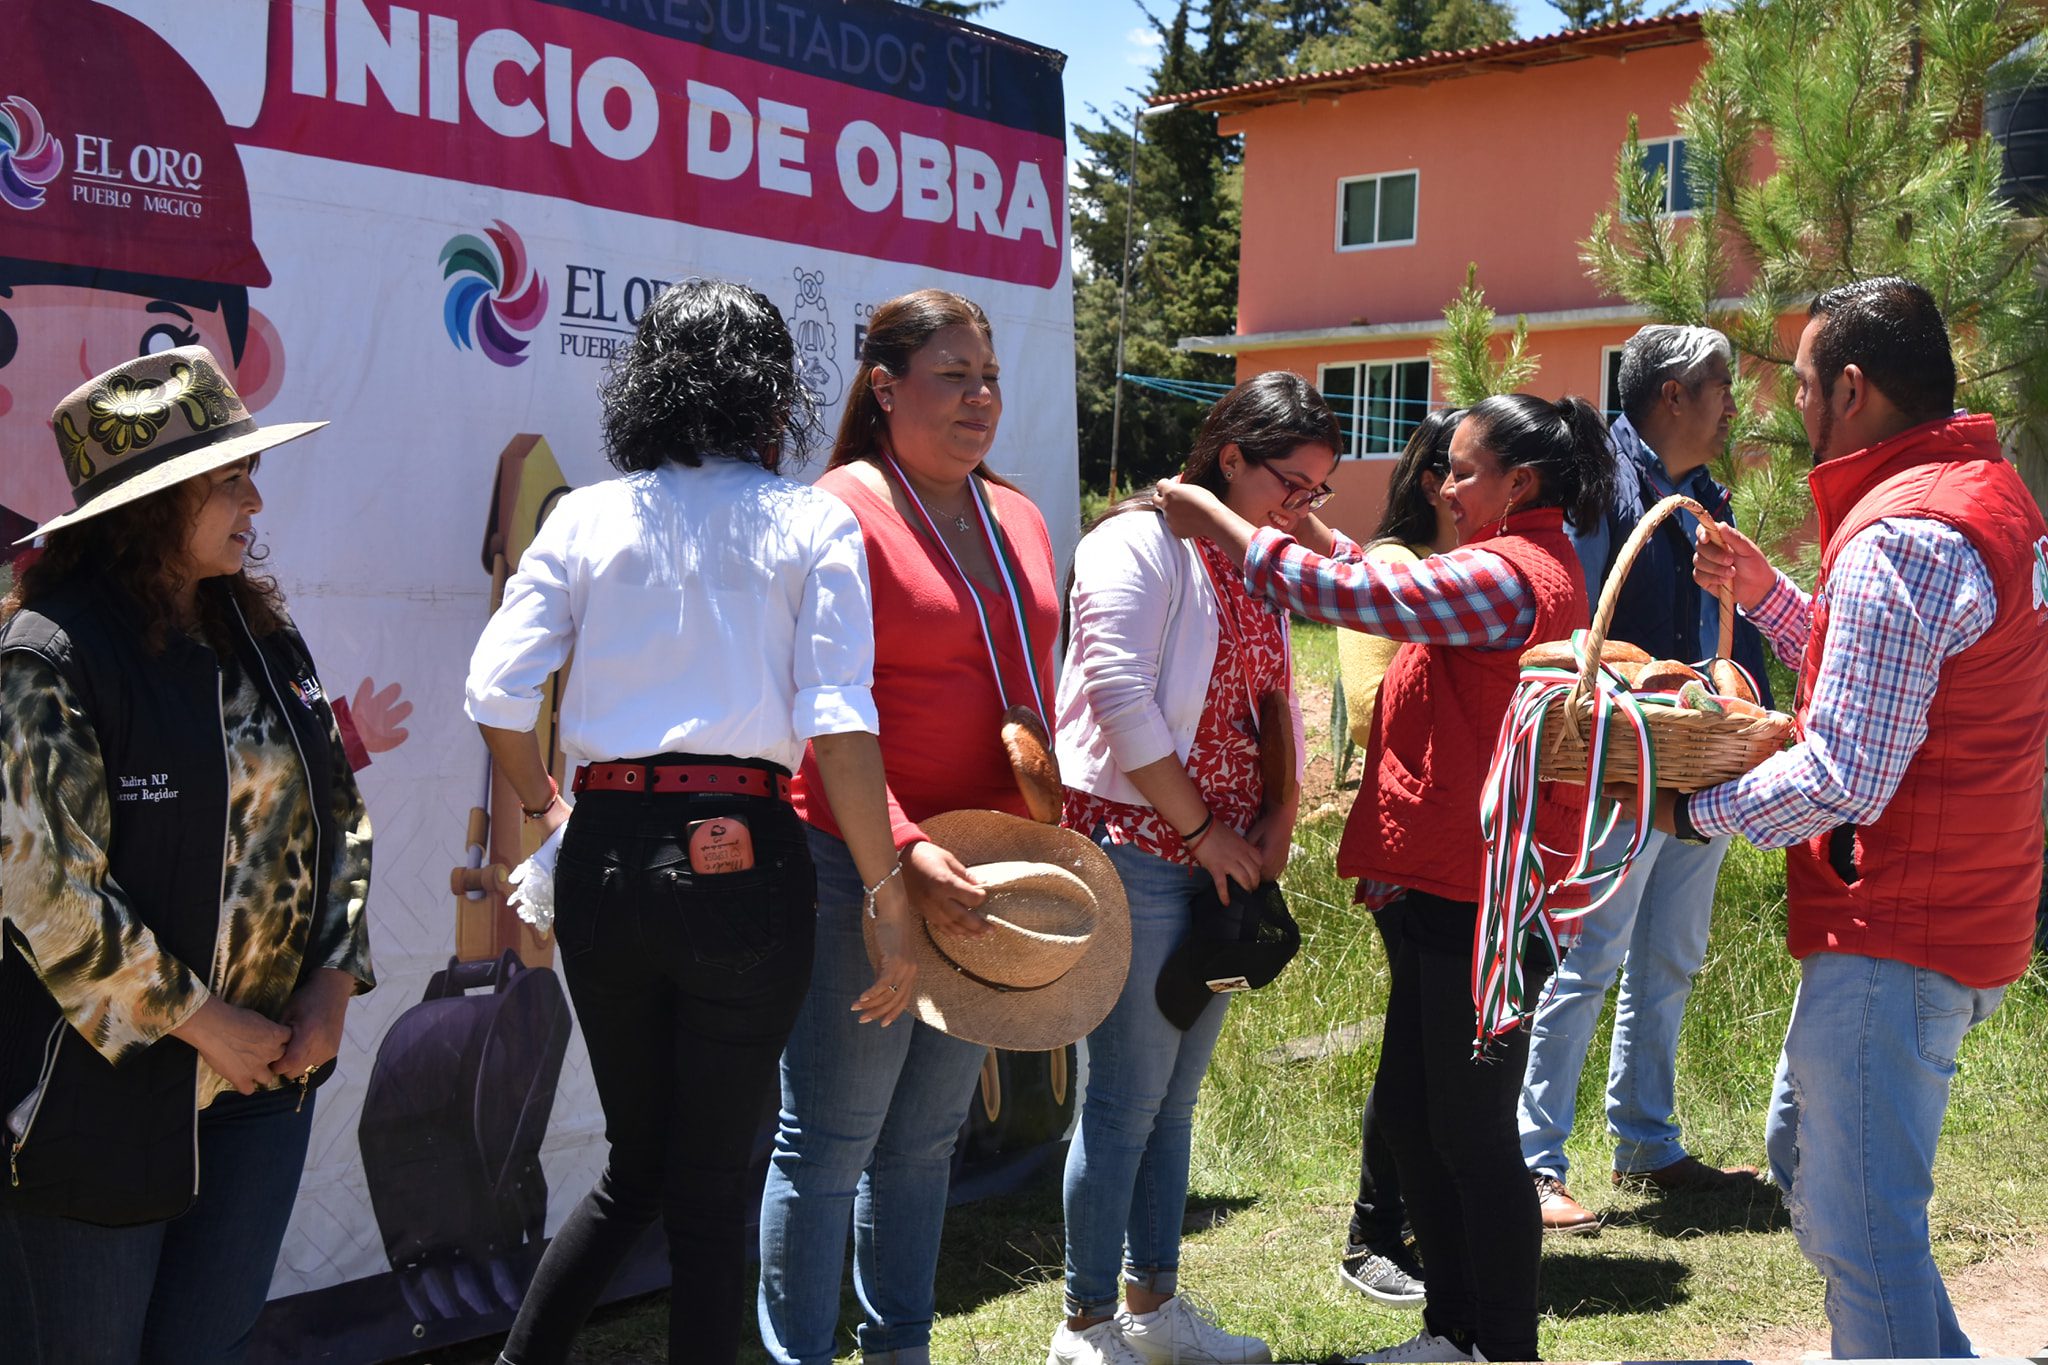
[1159,393,1614,1361]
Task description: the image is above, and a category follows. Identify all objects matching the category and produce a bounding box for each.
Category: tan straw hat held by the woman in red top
[862,810,1130,1052]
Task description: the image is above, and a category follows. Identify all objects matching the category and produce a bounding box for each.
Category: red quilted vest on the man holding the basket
[1786,415,2048,988]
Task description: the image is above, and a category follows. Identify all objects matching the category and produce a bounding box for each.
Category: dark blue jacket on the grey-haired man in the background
[1573,431,1772,706]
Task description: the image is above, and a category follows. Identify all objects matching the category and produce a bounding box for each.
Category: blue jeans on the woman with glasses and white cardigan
[1065,831,1231,1318]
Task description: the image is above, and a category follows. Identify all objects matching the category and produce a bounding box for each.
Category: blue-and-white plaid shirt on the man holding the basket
[1690,518,1999,849]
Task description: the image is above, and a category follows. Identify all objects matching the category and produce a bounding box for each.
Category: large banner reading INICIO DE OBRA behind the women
[0,0,1077,1359]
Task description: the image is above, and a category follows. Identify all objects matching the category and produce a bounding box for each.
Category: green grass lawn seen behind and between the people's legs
[446,626,2048,1365]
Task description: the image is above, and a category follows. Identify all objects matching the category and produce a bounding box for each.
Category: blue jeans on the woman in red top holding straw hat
[760,829,989,1365]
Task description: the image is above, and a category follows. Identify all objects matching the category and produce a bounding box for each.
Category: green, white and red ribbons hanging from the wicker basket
[1473,630,1659,1056]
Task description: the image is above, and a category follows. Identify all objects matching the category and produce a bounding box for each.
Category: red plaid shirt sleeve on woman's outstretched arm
[1245,526,1536,649]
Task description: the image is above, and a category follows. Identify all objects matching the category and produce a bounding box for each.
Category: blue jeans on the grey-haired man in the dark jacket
[1518,833,1729,1181]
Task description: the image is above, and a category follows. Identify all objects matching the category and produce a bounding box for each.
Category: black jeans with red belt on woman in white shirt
[504,769,817,1365]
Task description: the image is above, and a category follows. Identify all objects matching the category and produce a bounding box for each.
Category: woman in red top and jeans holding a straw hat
[760,289,1059,1365]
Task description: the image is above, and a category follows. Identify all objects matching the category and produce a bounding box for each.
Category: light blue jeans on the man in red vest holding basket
[1763,954,2005,1359]
